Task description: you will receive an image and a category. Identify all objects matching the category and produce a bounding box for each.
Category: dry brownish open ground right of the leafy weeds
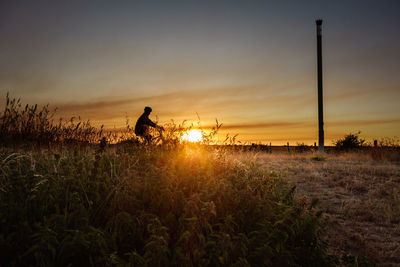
[256,153,400,266]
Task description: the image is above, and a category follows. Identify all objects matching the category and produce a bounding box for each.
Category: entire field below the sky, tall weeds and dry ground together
[0,99,400,266]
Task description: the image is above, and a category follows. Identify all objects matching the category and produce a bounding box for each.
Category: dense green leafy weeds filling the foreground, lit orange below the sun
[0,145,332,266]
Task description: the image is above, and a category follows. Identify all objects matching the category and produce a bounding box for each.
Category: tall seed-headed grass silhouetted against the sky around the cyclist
[0,94,222,149]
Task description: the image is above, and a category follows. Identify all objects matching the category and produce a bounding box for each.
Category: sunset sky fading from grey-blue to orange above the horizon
[0,0,400,145]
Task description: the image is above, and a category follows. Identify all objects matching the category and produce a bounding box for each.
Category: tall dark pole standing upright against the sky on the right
[315,19,324,153]
